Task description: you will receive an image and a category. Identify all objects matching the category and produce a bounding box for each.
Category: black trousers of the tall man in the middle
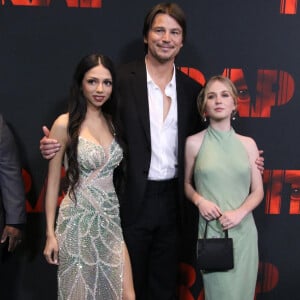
[123,179,178,300]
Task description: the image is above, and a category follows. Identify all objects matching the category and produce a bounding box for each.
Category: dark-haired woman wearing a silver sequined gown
[44,54,135,300]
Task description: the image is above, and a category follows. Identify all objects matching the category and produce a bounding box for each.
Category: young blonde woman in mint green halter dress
[185,76,263,300]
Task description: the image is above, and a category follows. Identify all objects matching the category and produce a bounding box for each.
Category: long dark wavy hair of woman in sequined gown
[66,54,115,201]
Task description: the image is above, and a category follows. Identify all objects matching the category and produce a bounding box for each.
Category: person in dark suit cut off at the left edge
[0,115,26,260]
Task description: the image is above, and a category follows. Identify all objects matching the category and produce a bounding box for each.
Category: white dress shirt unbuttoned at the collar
[147,67,178,180]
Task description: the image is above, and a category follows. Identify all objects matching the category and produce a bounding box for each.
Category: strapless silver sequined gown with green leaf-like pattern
[56,137,124,300]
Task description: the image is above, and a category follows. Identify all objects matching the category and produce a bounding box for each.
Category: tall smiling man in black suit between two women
[40,3,262,300]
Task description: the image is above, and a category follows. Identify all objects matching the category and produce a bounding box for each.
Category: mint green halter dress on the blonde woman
[194,127,258,300]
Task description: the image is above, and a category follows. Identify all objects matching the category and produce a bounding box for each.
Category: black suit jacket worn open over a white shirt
[116,61,201,226]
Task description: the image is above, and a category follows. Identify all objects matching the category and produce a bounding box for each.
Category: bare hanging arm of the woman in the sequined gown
[44,114,68,264]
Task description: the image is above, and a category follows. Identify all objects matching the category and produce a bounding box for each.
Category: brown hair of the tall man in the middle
[143,3,186,53]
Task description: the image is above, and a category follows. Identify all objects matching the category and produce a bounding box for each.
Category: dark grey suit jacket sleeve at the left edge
[0,115,26,235]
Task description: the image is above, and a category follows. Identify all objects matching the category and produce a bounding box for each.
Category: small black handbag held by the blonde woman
[197,221,234,272]
